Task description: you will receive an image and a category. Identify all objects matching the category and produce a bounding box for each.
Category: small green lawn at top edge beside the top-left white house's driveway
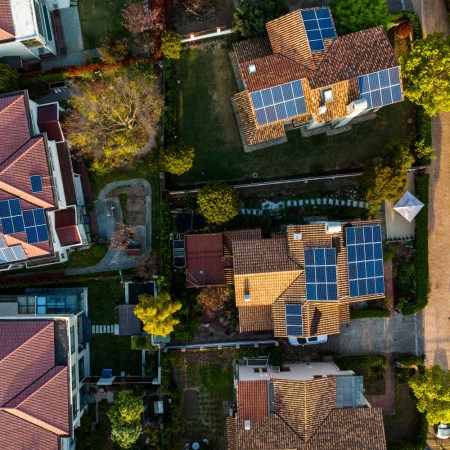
[78,0,127,50]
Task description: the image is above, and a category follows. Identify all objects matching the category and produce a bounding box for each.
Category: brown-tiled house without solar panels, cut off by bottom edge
[227,358,386,450]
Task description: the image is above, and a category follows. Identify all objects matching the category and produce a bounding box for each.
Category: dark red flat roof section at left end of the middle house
[184,233,226,287]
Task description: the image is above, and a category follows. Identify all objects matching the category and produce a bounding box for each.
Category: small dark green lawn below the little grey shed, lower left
[91,334,142,375]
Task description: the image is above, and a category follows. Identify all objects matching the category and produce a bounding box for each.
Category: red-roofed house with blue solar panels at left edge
[0,91,89,270]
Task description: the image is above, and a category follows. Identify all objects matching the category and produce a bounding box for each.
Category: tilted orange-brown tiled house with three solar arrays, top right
[234,7,403,151]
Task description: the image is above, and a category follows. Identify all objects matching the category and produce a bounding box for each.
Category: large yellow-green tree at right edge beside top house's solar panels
[400,33,450,116]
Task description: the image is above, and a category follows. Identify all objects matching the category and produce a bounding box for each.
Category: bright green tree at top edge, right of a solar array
[330,0,392,35]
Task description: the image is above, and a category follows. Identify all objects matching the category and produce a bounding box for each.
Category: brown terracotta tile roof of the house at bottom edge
[227,375,386,450]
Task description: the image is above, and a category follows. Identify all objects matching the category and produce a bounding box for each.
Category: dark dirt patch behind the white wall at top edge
[173,0,234,35]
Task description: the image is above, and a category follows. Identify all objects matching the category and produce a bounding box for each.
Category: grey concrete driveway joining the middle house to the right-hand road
[330,313,423,356]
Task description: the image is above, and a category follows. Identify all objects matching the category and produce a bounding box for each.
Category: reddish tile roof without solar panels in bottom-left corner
[0,320,70,450]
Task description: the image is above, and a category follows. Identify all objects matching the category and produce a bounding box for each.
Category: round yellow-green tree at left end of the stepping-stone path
[197,181,239,225]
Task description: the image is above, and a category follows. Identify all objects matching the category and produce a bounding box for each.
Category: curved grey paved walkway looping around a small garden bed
[65,178,152,275]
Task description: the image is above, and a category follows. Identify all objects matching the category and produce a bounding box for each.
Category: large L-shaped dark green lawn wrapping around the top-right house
[174,46,415,186]
